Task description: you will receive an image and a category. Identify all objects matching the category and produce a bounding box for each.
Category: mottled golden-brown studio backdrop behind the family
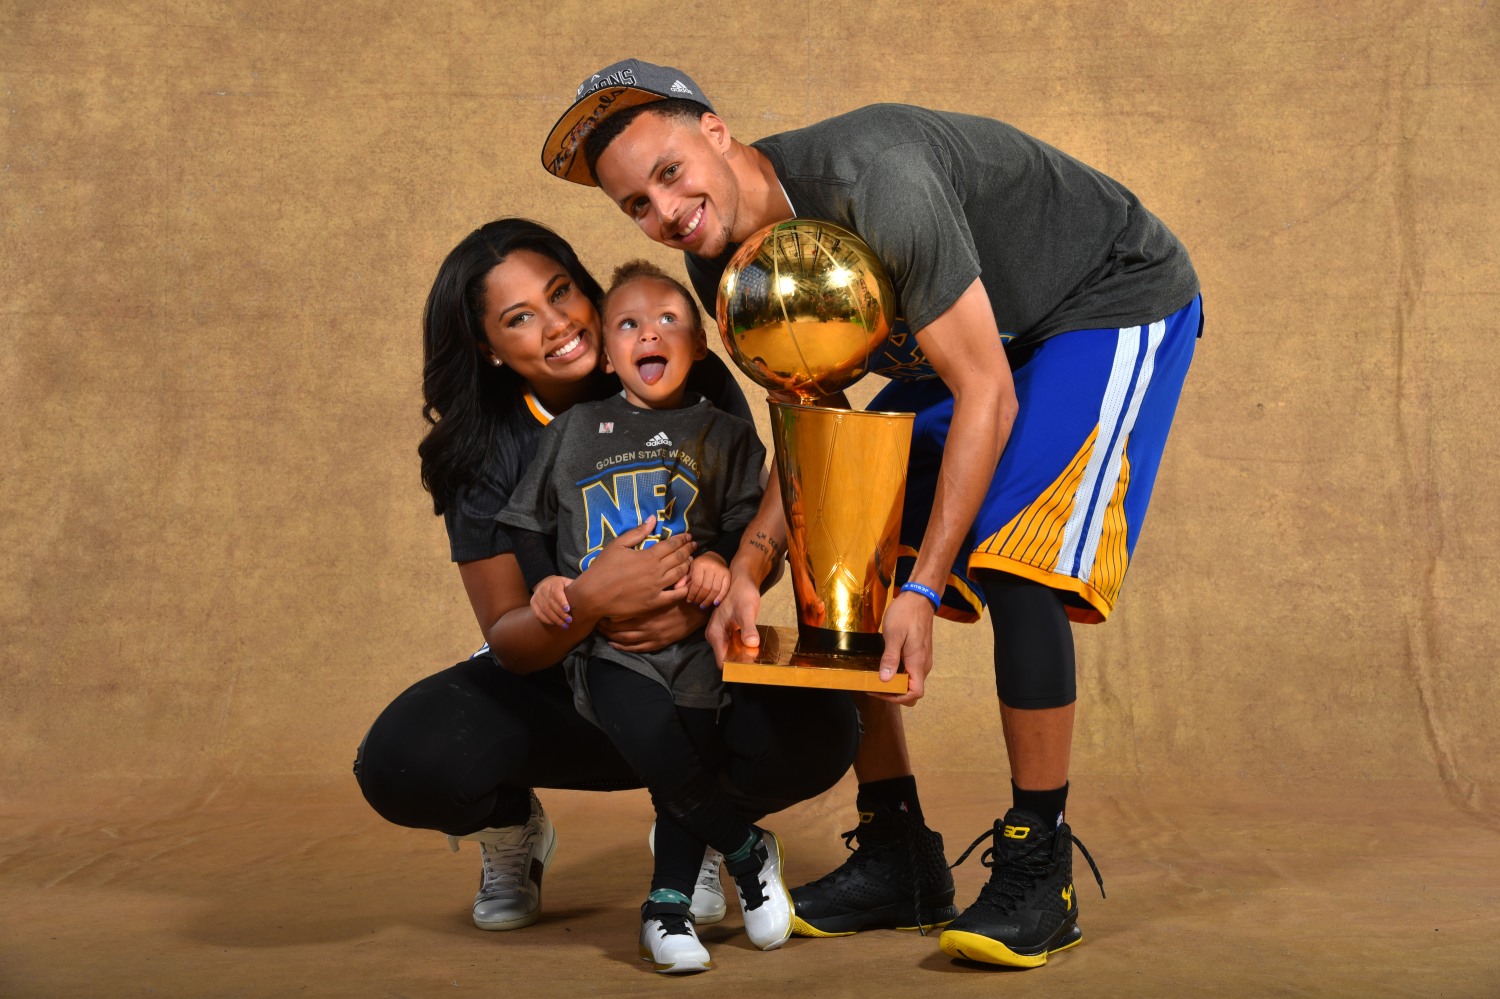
[0,0,1500,990]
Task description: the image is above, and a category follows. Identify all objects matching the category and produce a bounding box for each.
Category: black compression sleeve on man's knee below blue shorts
[975,572,1077,710]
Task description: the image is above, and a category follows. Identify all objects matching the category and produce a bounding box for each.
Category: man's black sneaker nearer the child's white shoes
[792,807,959,936]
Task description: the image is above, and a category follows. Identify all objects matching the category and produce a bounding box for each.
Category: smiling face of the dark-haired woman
[485,251,600,390]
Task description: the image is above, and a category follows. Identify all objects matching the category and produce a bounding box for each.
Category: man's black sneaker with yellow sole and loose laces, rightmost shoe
[938,809,1104,968]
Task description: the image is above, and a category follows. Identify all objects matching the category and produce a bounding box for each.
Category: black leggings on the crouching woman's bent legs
[354,656,860,836]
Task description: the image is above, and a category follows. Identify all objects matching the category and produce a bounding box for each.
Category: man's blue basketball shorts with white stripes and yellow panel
[869,297,1203,623]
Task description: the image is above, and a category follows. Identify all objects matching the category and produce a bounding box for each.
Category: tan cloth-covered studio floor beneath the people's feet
[0,774,1500,999]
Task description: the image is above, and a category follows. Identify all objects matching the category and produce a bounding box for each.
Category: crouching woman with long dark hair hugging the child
[354,219,858,930]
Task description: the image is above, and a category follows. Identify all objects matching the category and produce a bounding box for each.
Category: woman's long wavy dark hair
[417,219,603,515]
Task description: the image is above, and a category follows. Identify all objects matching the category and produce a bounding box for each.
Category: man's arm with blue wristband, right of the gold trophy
[875,279,1017,704]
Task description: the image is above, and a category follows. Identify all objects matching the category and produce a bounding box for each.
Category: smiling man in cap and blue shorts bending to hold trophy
[542,60,1202,968]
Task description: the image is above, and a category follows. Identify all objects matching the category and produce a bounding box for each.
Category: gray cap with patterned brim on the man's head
[542,59,714,188]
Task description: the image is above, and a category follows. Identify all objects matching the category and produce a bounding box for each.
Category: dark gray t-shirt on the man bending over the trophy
[687,104,1199,367]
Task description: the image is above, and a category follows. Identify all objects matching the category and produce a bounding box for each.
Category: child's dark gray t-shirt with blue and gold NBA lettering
[495,396,765,719]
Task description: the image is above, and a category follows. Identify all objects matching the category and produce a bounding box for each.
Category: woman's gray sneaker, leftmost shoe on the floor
[449,794,558,930]
